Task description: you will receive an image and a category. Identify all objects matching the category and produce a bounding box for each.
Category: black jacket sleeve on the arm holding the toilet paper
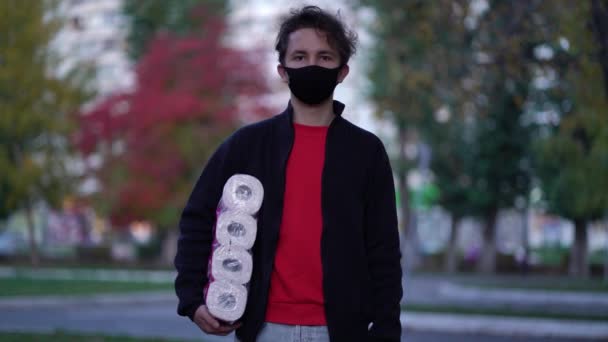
[174,140,229,320]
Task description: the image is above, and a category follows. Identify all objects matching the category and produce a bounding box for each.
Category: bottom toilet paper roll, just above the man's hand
[205,280,247,322]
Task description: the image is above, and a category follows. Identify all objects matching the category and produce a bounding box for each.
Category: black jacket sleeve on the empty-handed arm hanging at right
[365,140,403,341]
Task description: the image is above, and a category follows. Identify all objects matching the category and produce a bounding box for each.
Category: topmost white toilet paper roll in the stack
[221,174,264,215]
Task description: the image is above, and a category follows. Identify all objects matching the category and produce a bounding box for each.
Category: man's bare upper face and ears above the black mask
[278,28,348,83]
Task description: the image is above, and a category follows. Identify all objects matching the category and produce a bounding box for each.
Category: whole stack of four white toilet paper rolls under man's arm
[205,174,264,322]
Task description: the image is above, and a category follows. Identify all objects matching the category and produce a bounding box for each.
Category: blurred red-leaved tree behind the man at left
[76,20,272,228]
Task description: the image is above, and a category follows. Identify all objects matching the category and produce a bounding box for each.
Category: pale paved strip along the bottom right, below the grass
[401,312,608,341]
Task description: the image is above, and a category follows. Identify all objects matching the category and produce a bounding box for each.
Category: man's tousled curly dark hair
[275,6,357,65]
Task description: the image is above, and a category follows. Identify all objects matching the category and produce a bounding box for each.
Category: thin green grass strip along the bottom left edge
[0,332,182,342]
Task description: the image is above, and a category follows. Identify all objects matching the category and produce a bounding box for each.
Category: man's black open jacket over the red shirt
[175,101,402,342]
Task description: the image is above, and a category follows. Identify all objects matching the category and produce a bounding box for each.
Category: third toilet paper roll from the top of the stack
[211,246,253,284]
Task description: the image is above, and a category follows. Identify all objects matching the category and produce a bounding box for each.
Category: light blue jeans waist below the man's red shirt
[235,322,329,342]
